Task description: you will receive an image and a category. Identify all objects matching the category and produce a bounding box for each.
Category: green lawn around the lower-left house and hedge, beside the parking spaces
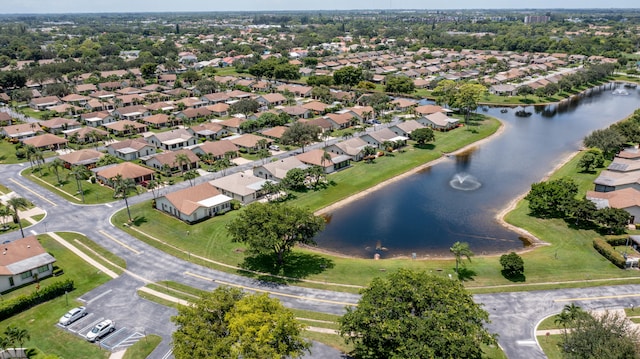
[0,234,114,359]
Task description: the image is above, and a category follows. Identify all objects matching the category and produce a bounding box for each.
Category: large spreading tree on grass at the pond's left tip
[227,202,325,265]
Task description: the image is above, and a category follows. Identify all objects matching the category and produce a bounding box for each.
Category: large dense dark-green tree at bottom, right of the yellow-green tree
[339,269,496,359]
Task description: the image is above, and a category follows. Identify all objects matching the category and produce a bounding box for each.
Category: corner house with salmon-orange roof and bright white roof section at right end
[155,182,233,223]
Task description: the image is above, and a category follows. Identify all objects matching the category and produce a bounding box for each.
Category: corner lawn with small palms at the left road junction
[23,166,115,204]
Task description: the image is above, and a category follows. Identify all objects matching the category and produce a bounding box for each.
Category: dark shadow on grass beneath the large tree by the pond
[241,252,335,283]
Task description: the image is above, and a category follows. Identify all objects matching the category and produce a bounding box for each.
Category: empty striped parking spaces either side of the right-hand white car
[56,313,144,352]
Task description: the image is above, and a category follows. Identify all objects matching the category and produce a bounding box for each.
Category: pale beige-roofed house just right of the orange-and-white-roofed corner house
[209,172,271,204]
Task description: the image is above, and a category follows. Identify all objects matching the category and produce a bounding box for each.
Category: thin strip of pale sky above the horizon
[0,0,640,14]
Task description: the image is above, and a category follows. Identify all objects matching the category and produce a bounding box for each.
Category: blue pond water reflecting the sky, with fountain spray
[316,88,639,258]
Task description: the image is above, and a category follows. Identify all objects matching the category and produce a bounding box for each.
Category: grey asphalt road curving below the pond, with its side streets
[0,164,640,359]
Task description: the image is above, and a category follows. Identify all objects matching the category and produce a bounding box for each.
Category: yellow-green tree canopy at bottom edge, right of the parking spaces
[171,287,310,359]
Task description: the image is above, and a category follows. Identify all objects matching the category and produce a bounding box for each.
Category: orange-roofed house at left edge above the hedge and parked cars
[0,236,56,293]
